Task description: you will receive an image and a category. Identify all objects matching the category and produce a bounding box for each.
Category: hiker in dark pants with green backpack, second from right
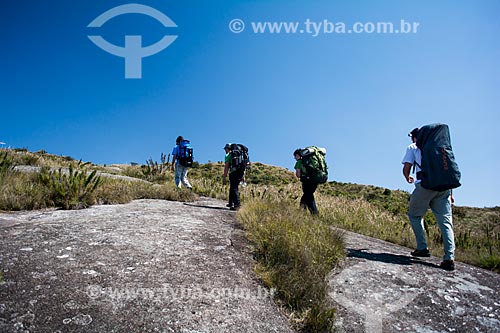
[293,146,328,214]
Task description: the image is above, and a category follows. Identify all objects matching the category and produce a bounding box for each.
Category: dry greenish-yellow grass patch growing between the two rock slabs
[238,199,345,332]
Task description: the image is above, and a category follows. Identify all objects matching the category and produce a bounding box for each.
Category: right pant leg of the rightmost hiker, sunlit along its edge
[431,190,455,260]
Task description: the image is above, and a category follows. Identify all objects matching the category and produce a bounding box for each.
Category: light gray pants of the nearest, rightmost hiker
[408,184,455,260]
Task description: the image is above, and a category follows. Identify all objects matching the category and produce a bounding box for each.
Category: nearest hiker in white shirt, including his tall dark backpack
[402,124,461,271]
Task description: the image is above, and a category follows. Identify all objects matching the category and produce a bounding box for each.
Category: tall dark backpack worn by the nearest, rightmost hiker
[417,124,461,191]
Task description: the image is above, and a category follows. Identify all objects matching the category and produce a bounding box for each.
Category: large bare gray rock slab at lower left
[0,199,292,333]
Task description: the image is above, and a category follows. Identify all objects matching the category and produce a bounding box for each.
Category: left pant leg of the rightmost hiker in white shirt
[408,184,434,250]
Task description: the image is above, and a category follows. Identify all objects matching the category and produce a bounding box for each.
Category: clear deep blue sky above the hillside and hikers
[0,0,500,207]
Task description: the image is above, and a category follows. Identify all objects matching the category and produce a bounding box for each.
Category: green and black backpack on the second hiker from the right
[300,146,328,184]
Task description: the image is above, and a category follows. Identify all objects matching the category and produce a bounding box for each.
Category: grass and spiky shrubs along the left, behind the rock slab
[0,149,196,211]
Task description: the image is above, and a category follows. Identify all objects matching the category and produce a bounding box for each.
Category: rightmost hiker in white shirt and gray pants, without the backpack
[402,128,455,271]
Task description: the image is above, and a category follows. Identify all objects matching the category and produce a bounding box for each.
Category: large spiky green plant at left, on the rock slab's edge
[38,161,101,209]
